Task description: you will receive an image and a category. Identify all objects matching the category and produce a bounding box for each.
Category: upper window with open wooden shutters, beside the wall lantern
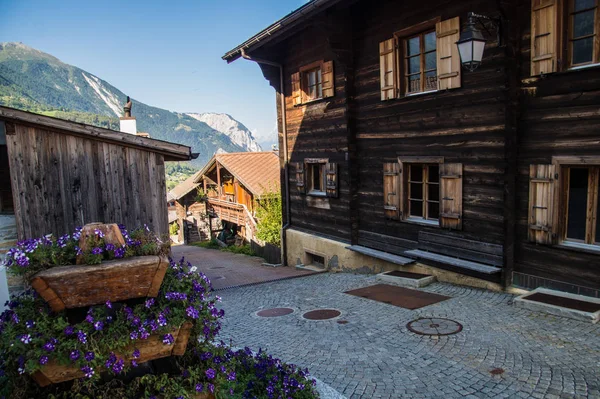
[379,17,461,101]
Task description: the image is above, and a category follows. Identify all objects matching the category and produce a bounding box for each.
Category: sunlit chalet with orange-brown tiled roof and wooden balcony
[169,152,280,242]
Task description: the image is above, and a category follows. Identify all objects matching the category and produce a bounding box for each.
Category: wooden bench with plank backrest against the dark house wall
[406,232,503,274]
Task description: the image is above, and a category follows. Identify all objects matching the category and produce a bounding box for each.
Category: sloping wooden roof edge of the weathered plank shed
[0,106,194,161]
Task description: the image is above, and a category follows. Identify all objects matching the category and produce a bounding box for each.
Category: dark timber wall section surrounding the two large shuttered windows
[352,0,506,253]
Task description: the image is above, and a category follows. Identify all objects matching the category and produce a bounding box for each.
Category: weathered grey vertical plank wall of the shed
[7,124,168,239]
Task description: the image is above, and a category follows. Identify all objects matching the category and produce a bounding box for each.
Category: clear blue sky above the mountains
[0,0,306,147]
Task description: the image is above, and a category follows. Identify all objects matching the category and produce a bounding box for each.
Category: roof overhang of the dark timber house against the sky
[221,0,342,63]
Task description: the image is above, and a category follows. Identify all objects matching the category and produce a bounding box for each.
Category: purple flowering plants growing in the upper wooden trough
[5,225,170,277]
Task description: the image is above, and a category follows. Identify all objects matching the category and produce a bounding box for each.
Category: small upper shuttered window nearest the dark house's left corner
[292,61,335,106]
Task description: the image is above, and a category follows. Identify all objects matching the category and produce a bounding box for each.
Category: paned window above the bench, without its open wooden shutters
[408,164,440,221]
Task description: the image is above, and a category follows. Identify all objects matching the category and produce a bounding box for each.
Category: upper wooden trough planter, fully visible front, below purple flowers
[30,256,169,312]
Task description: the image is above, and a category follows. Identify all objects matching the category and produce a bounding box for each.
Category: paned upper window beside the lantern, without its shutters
[404,31,437,94]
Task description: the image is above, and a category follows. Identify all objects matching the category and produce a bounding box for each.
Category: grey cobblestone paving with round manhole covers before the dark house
[219,274,600,399]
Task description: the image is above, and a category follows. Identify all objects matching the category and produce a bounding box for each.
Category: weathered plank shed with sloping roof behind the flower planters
[0,107,192,239]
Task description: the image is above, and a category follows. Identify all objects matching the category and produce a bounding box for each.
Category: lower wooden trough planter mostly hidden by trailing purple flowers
[31,322,192,387]
